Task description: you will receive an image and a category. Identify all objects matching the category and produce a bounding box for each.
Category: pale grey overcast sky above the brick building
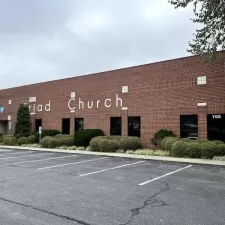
[0,0,196,89]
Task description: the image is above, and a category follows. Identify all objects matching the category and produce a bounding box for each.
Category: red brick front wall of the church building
[0,52,225,145]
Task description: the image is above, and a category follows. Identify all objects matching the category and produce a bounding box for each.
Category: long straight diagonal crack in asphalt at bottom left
[0,197,91,225]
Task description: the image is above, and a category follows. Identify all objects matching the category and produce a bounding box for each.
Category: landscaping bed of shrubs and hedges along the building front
[0,129,225,161]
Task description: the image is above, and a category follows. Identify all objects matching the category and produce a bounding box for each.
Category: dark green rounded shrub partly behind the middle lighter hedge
[74,129,104,147]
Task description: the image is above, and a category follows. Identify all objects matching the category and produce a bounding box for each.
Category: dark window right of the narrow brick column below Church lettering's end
[128,116,141,137]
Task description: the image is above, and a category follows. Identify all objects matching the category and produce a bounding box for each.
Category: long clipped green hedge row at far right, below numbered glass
[162,137,225,159]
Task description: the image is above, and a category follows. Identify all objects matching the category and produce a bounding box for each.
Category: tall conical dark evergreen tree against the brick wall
[15,104,31,137]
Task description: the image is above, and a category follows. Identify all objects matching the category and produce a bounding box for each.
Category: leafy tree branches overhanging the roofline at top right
[169,0,225,61]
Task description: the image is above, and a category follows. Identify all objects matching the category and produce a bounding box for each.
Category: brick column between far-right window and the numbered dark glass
[198,108,207,139]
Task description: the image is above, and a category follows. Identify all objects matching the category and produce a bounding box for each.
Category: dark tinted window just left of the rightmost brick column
[180,115,198,138]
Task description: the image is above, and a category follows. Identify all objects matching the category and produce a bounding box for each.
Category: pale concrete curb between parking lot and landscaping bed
[0,145,225,166]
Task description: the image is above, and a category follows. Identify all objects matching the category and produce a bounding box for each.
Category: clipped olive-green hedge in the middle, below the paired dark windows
[90,136,142,152]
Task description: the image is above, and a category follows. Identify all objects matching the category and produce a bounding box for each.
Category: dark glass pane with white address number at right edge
[207,114,225,142]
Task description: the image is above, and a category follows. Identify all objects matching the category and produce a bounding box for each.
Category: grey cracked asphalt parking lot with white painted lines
[0,149,225,225]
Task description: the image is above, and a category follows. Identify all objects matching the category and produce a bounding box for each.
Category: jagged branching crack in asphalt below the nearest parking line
[120,184,169,225]
